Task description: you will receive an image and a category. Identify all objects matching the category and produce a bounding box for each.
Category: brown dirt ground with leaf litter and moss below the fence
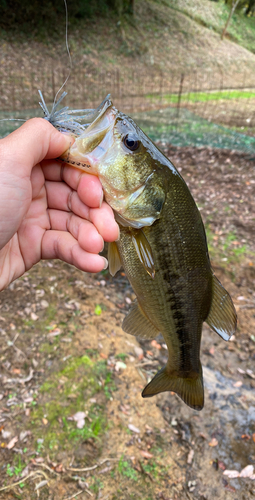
[0,146,255,500]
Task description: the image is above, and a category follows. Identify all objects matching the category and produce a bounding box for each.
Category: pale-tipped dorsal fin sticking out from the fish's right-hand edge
[205,276,237,340]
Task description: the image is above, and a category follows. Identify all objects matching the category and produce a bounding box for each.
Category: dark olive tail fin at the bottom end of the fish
[142,365,204,411]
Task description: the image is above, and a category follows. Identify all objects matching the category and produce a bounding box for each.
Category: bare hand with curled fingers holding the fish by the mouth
[0,118,119,290]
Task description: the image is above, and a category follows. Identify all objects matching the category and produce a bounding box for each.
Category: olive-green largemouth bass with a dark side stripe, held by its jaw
[61,97,237,410]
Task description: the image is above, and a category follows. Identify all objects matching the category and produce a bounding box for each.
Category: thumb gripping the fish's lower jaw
[0,118,73,176]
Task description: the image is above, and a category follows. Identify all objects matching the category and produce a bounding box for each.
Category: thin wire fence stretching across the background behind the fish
[0,61,255,151]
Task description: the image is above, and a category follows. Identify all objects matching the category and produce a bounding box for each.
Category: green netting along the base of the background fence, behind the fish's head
[0,108,255,154]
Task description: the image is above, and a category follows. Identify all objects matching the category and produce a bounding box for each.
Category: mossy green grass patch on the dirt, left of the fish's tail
[28,356,115,456]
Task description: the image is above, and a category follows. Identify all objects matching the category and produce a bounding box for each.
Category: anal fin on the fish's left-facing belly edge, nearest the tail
[122,302,159,339]
